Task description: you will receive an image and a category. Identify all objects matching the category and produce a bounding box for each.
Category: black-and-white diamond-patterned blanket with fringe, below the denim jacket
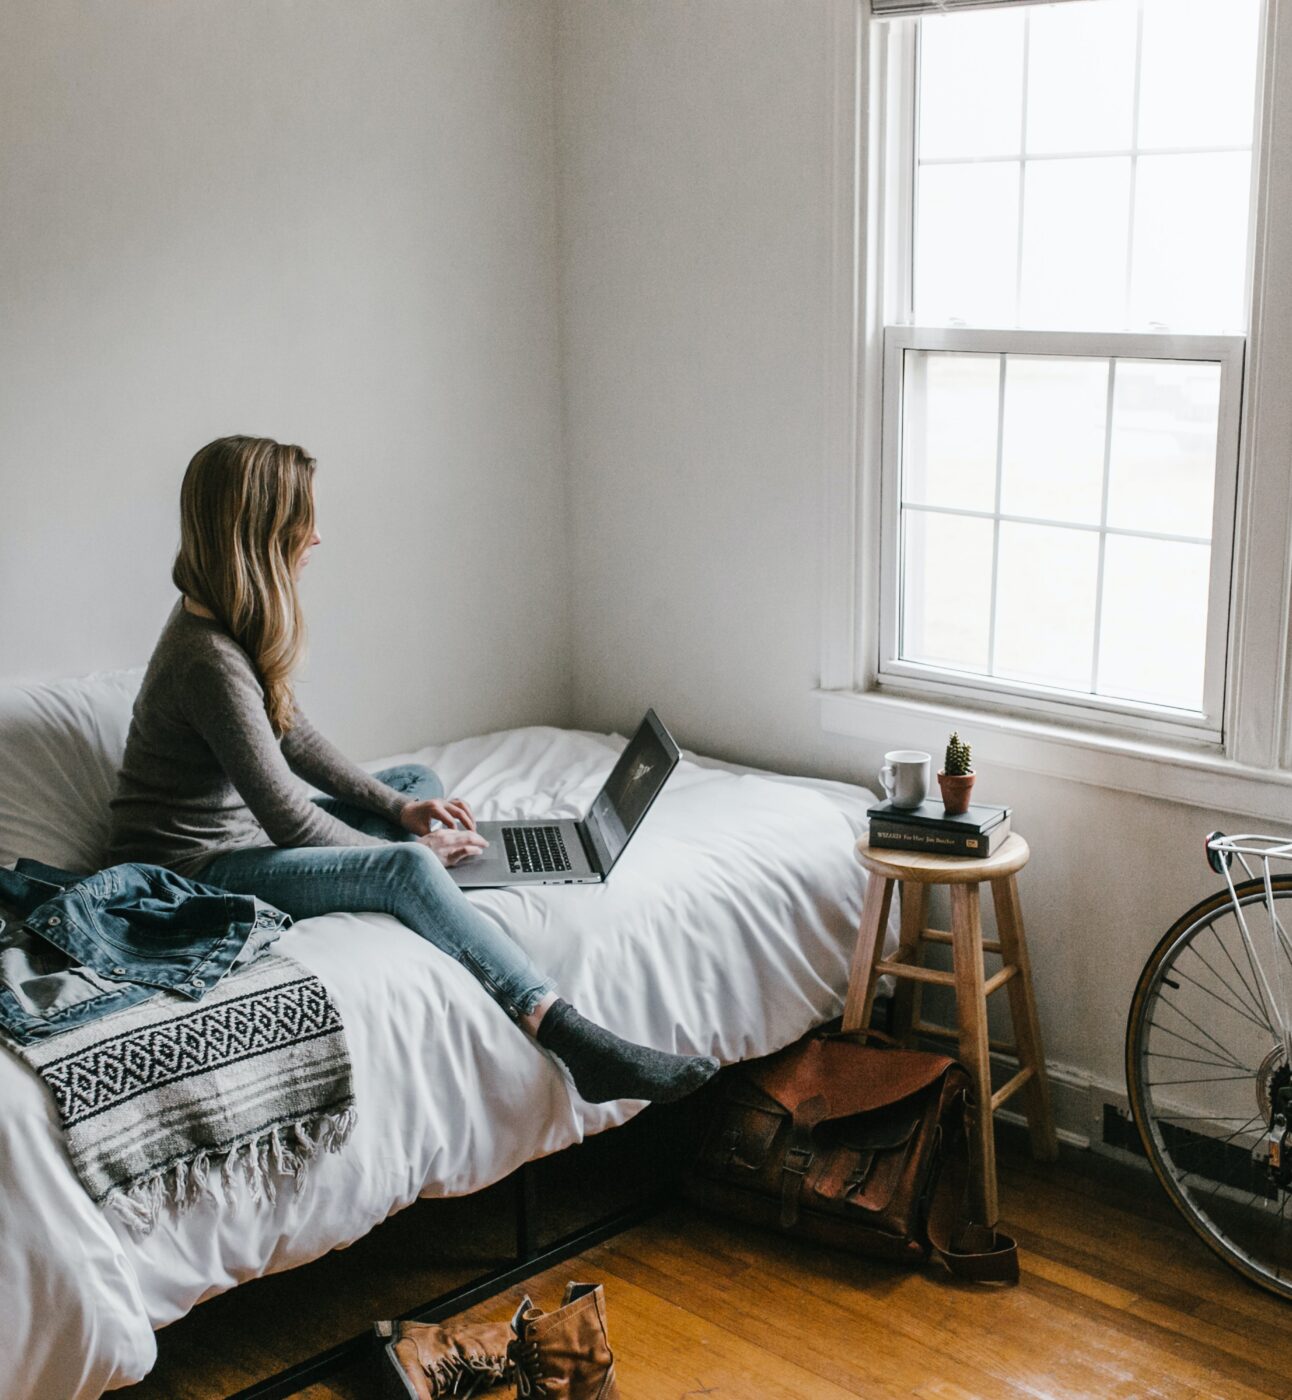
[14,953,354,1233]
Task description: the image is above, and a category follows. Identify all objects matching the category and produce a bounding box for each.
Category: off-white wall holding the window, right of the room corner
[559,0,1268,1131]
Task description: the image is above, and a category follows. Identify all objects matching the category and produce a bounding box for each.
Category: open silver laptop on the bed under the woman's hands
[449,710,682,889]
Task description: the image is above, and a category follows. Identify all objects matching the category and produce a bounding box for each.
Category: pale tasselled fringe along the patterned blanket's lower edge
[102,1105,356,1235]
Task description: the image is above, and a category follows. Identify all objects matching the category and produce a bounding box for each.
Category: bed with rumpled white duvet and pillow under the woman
[0,672,890,1400]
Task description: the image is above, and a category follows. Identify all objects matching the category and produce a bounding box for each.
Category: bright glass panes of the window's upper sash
[907,0,1257,332]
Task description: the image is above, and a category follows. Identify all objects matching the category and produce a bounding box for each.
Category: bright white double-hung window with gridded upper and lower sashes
[875,0,1261,743]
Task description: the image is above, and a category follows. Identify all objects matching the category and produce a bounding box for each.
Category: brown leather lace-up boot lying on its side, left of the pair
[372,1322,515,1400]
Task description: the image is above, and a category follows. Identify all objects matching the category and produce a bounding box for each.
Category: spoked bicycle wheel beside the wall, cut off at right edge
[1125,875,1292,1299]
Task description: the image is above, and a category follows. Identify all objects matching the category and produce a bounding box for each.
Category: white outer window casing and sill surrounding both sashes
[812,0,1292,826]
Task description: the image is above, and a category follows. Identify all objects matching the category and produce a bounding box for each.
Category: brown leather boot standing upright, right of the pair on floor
[508,1284,619,1400]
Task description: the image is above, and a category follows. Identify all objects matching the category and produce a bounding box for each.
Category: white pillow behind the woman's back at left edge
[0,668,144,871]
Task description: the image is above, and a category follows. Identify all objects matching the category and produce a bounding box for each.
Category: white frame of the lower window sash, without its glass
[876,325,1246,746]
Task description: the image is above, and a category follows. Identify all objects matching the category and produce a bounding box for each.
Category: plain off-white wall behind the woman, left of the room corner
[0,0,570,756]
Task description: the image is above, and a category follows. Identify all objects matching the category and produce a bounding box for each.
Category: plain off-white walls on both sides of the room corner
[0,0,1282,1126]
